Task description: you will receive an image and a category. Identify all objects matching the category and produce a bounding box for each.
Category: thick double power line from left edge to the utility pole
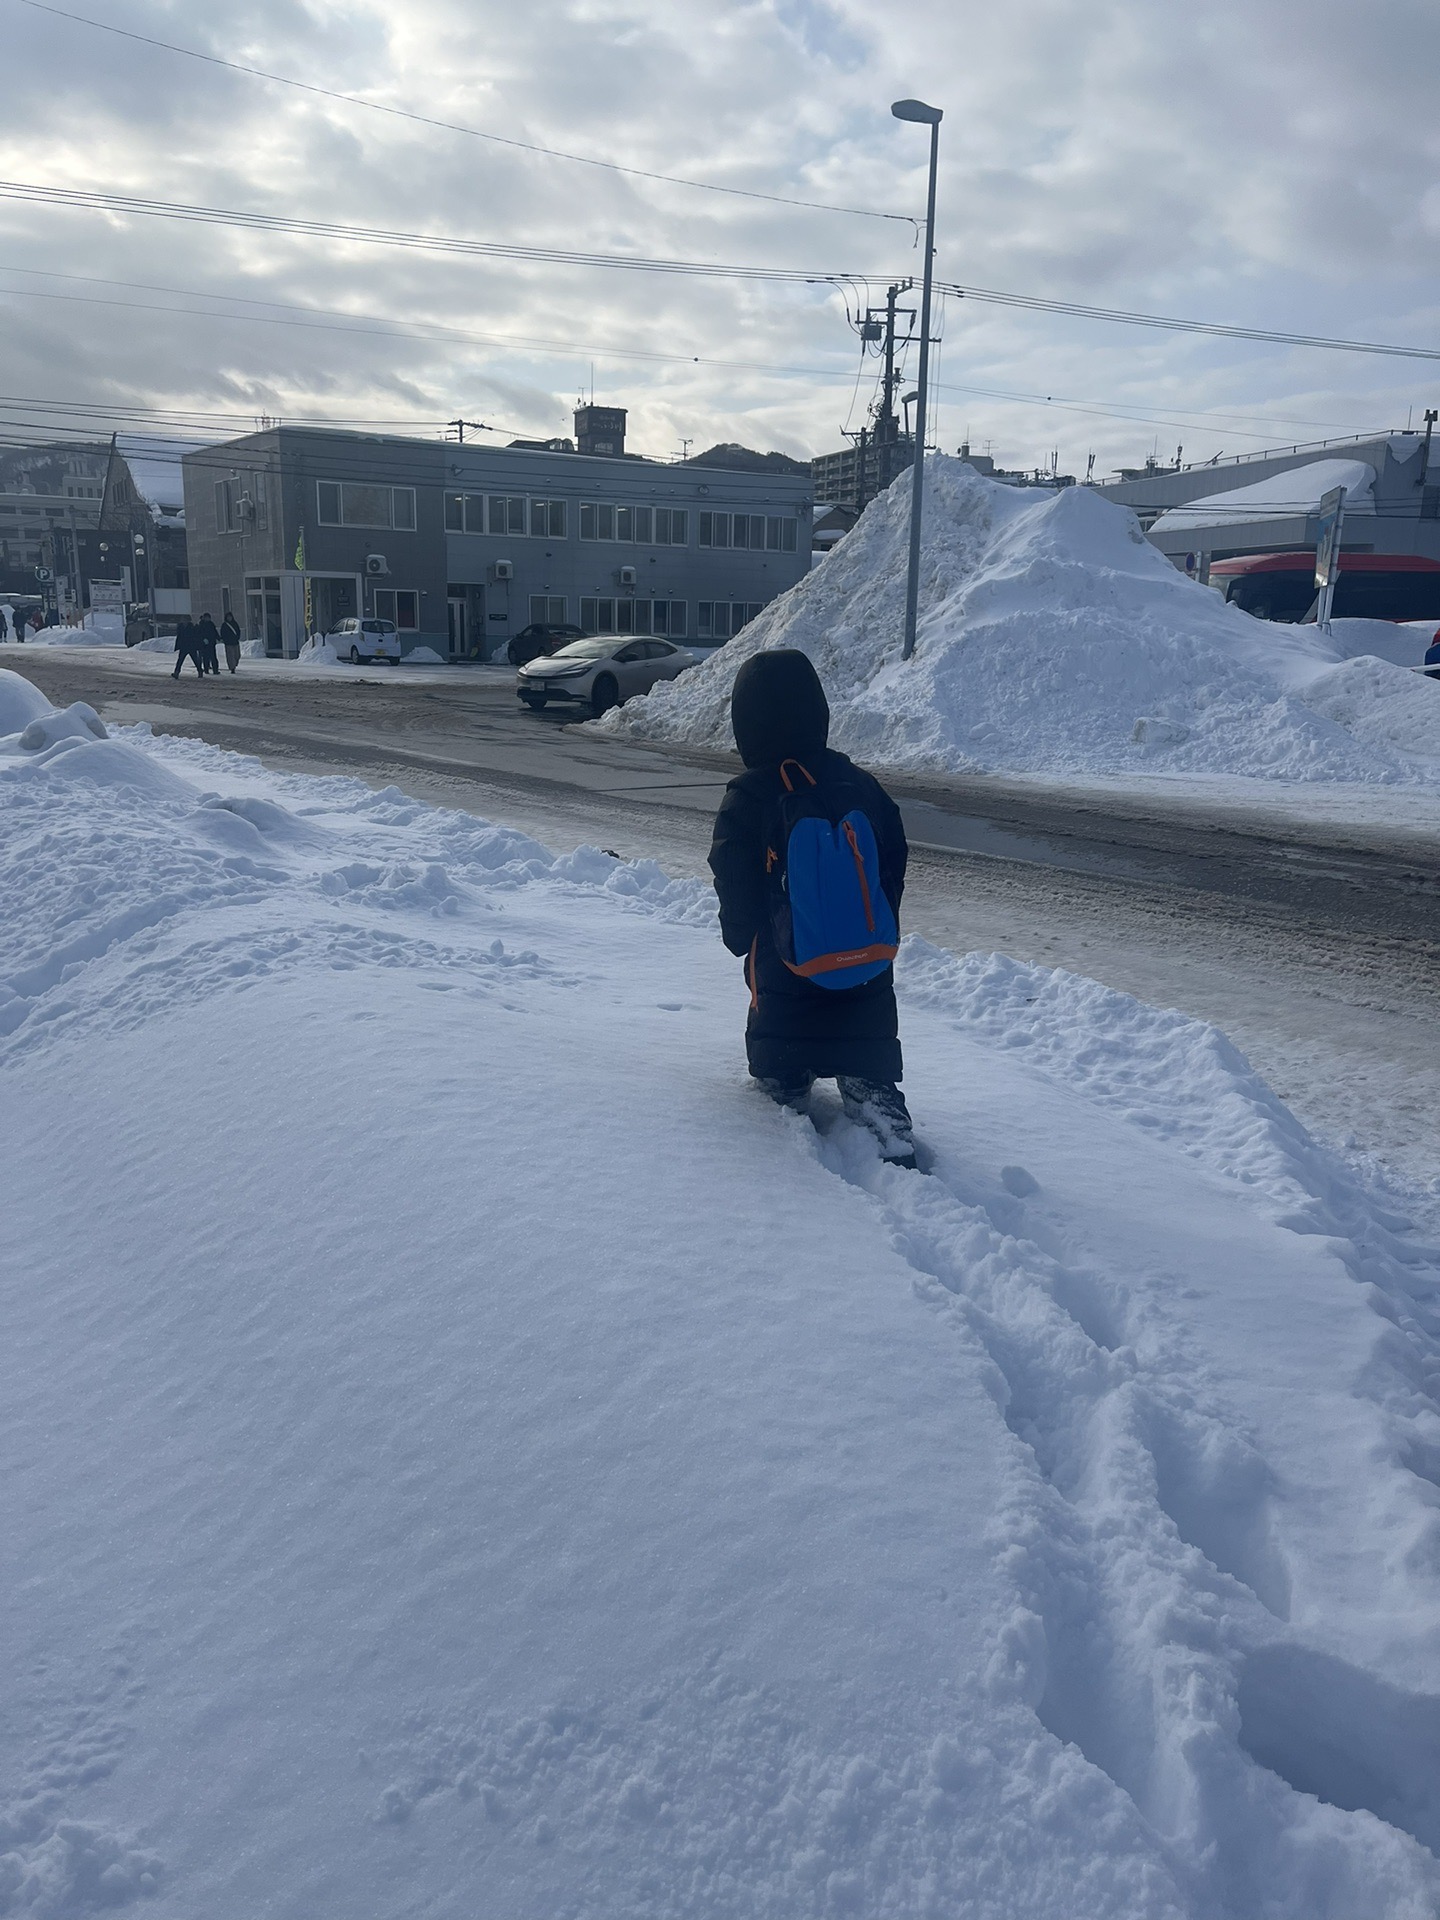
[0,178,866,286]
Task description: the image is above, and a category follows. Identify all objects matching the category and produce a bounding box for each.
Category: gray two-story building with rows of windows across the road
[184,407,814,659]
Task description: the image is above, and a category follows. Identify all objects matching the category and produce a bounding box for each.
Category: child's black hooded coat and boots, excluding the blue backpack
[710,647,916,1167]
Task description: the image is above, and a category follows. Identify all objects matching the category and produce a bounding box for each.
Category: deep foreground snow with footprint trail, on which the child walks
[0,674,1440,1920]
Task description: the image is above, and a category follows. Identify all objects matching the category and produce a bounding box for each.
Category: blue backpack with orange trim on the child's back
[764,760,900,991]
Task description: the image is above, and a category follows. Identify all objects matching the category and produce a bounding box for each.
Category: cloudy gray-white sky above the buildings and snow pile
[0,0,1440,474]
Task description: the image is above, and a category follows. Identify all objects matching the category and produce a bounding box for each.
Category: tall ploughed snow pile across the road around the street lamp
[595,457,1440,783]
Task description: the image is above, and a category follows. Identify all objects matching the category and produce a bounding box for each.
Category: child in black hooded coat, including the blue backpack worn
[710,647,916,1167]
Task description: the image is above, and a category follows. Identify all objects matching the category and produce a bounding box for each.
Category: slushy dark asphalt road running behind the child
[11,647,1440,1225]
